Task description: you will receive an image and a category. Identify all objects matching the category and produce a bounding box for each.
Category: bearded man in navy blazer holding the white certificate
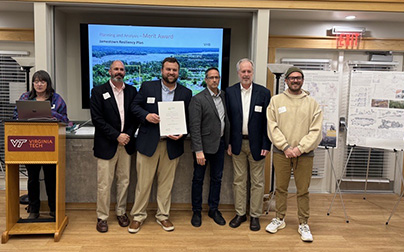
[128,58,192,233]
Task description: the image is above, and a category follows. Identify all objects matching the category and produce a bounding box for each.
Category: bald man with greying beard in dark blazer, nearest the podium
[90,60,138,232]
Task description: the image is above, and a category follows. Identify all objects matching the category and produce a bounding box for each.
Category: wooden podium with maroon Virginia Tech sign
[1,121,68,243]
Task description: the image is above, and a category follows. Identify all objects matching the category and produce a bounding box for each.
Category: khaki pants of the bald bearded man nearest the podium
[97,145,131,220]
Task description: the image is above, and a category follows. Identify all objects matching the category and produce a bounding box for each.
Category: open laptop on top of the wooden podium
[16,100,53,121]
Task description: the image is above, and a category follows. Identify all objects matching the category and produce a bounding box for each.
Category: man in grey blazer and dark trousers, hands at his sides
[189,67,230,227]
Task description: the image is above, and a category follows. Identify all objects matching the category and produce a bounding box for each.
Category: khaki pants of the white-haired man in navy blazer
[232,139,265,218]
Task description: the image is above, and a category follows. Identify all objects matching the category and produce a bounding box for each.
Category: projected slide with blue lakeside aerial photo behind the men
[88,24,223,94]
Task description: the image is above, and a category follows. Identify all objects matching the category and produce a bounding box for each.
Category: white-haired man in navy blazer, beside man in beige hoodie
[226,59,271,231]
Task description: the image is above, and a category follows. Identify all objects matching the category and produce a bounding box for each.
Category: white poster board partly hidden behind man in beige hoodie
[302,71,341,148]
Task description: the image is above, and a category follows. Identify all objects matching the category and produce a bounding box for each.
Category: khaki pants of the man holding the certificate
[130,141,179,222]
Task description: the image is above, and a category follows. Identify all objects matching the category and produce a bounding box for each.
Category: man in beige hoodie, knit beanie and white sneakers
[266,67,323,242]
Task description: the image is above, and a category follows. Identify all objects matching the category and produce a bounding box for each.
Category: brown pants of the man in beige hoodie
[274,153,313,224]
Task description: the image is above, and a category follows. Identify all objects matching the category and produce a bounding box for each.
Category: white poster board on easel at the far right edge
[347,71,404,150]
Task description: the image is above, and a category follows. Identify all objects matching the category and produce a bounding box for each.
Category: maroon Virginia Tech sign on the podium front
[8,136,55,151]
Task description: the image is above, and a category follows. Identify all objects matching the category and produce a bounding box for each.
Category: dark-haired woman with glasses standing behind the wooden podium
[14,70,69,219]
